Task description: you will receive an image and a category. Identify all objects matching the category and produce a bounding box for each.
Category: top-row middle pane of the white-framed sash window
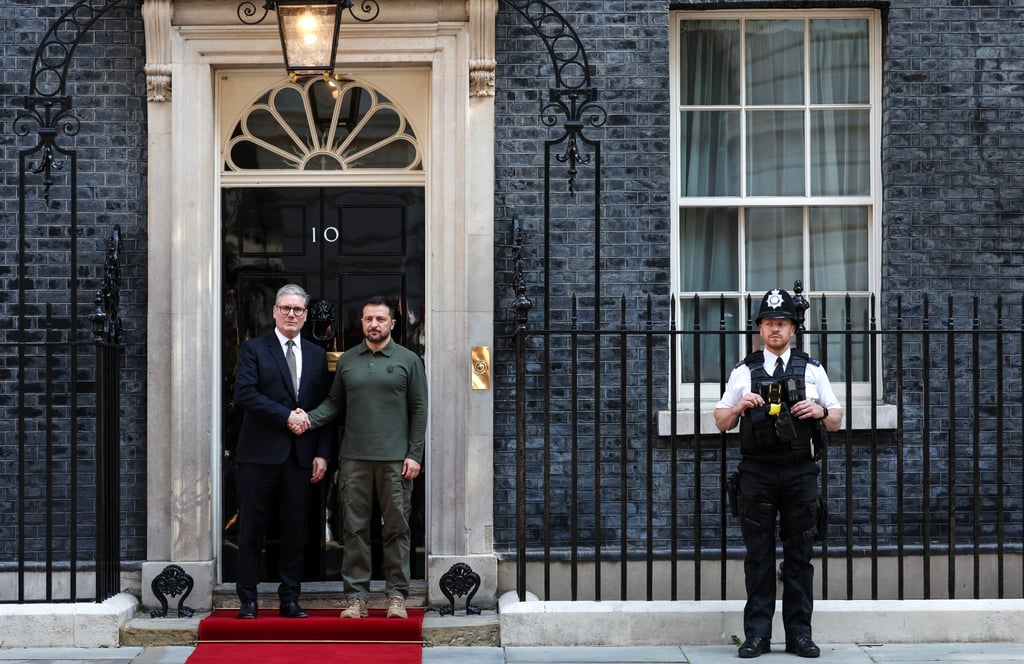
[746,20,804,106]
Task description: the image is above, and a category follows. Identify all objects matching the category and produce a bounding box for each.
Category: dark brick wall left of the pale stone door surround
[0,0,146,563]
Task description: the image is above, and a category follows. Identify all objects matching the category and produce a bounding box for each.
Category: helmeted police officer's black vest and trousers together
[738,349,821,644]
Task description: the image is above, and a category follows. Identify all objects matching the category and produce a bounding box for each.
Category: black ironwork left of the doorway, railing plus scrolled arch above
[6,0,139,603]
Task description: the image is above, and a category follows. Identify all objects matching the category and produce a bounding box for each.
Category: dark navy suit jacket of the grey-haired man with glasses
[234,330,333,466]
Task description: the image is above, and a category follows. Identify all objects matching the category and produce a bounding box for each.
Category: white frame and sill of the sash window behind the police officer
[658,9,894,435]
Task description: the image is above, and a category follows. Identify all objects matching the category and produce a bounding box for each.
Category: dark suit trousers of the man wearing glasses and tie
[234,449,311,603]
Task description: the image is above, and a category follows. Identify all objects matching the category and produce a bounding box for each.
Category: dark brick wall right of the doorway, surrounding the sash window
[495,0,1024,561]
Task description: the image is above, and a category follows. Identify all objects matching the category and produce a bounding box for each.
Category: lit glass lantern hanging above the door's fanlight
[278,0,341,76]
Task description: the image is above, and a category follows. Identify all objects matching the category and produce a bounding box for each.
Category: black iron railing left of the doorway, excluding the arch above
[0,229,124,604]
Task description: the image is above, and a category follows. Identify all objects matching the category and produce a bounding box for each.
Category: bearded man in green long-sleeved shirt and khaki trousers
[290,297,427,618]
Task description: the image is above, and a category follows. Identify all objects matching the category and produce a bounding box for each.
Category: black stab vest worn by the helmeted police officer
[739,348,821,463]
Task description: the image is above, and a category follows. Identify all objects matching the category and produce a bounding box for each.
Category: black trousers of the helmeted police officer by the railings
[739,456,819,640]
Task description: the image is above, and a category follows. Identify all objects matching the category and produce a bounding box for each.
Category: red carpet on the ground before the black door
[187,609,423,664]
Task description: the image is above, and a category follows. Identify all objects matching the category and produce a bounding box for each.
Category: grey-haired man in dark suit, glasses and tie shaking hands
[234,284,331,618]
